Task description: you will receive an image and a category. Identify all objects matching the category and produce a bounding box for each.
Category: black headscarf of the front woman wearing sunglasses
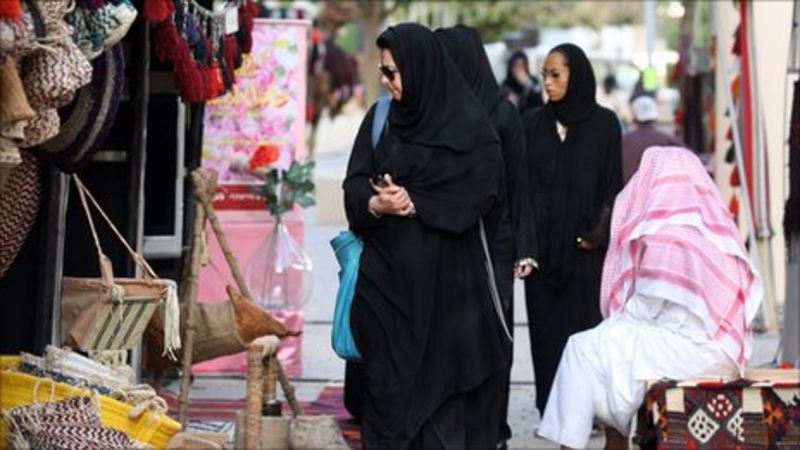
[377,23,498,151]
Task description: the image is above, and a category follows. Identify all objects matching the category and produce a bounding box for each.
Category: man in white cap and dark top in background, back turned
[622,95,684,183]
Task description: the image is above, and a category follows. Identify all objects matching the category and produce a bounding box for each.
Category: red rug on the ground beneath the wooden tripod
[160,385,361,450]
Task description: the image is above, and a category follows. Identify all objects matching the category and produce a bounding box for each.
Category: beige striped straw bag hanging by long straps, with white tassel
[61,175,181,358]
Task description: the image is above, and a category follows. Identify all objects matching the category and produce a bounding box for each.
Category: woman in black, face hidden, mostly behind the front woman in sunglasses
[436,25,536,442]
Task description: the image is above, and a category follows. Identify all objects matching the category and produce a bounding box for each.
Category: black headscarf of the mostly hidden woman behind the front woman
[436,25,503,115]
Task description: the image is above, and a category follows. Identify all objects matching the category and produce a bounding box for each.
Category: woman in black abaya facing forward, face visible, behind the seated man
[523,44,622,413]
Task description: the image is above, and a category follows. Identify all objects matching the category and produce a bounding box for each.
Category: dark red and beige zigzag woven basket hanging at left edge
[0,153,41,278]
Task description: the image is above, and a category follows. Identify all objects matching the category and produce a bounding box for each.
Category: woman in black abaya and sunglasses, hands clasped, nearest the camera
[344,24,508,449]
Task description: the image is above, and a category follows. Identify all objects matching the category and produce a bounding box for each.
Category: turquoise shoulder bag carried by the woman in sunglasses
[324,97,391,361]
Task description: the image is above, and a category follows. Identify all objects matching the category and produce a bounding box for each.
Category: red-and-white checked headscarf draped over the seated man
[600,147,763,369]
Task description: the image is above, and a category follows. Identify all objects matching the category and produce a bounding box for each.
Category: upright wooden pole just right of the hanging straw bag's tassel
[178,180,211,427]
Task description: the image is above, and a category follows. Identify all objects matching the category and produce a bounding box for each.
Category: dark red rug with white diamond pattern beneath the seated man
[635,380,800,450]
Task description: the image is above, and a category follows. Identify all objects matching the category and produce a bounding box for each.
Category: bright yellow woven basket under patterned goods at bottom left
[0,364,181,449]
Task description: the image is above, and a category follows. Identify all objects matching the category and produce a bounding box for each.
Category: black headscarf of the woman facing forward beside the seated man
[547,44,597,125]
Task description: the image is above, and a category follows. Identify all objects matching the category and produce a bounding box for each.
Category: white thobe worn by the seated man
[538,294,738,448]
